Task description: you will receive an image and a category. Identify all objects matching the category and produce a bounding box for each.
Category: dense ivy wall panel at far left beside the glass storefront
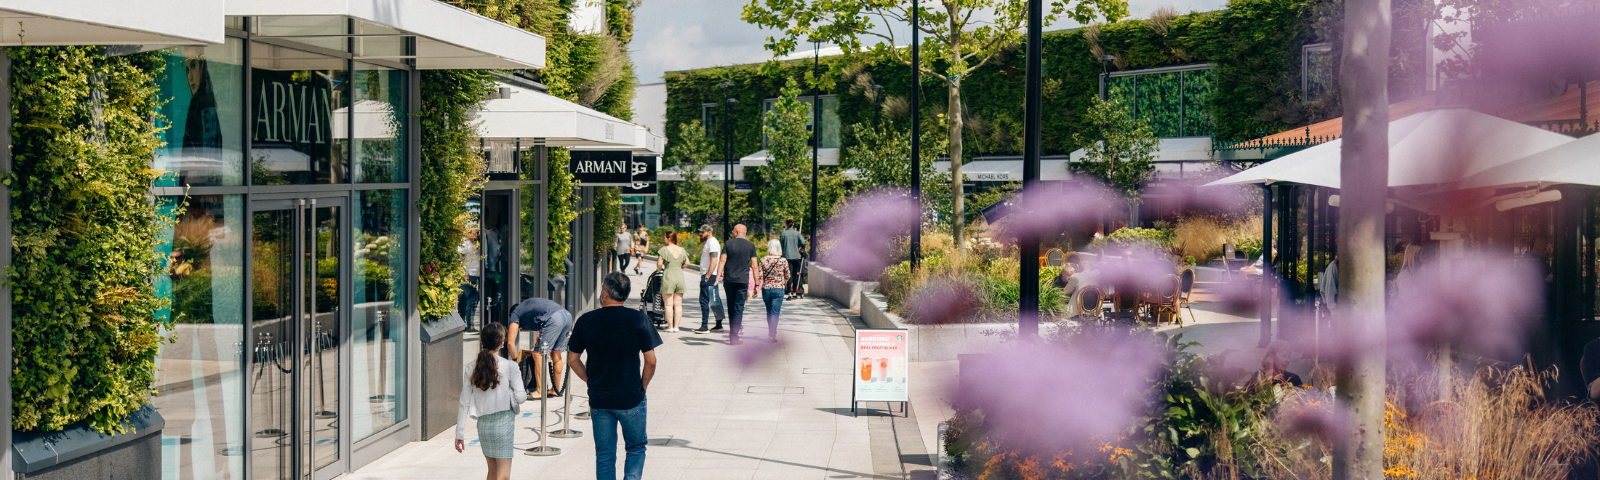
[5,46,173,432]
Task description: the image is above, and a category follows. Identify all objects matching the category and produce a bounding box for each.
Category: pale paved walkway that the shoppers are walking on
[349,268,938,480]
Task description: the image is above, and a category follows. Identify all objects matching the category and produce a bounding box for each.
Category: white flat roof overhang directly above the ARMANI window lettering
[228,0,546,70]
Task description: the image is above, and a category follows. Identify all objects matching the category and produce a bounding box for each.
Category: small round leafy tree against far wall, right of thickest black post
[1074,94,1160,203]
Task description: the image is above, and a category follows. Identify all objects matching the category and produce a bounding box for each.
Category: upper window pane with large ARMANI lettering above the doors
[250,43,350,186]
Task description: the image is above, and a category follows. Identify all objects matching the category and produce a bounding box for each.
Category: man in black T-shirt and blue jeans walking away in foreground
[566,272,661,480]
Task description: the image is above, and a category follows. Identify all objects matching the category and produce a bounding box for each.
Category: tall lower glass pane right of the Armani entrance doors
[350,190,410,442]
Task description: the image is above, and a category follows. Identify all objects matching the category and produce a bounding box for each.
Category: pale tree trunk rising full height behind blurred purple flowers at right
[1333,0,1390,480]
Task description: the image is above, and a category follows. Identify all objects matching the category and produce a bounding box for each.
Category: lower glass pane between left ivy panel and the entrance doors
[152,195,245,480]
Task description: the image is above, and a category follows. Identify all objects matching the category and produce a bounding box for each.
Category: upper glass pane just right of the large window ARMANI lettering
[353,62,406,182]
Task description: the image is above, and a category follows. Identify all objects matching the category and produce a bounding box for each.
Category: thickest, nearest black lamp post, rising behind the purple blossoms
[1017,0,1045,338]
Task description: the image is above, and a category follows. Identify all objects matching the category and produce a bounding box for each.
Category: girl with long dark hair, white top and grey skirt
[456,323,528,480]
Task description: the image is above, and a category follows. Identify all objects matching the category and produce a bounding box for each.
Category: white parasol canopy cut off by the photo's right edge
[1456,134,1600,189]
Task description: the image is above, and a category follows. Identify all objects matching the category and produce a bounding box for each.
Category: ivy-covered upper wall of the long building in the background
[666,0,1432,160]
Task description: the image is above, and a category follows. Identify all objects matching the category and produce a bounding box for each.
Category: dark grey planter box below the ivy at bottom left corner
[11,405,166,480]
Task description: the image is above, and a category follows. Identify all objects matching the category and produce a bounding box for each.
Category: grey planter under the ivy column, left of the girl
[422,314,467,438]
